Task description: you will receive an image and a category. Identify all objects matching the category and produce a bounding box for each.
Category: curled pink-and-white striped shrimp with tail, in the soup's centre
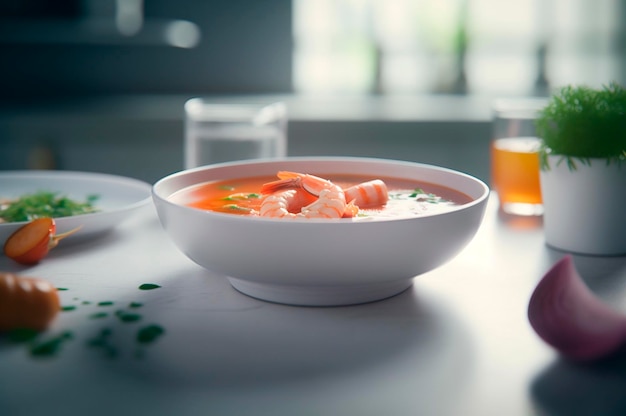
[261,171,358,218]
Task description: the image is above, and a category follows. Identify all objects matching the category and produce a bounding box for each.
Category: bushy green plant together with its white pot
[536,83,626,255]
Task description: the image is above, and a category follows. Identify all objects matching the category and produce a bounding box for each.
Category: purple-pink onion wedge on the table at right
[528,255,626,361]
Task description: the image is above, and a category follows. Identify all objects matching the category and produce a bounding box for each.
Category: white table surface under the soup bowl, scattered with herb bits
[0,195,626,416]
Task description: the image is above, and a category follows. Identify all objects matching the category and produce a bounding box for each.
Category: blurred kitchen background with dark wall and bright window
[0,0,626,182]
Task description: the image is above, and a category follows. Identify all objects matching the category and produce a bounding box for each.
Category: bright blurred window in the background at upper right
[293,0,626,95]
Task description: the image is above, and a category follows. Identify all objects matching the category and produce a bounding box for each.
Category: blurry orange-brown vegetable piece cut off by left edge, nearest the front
[0,272,60,331]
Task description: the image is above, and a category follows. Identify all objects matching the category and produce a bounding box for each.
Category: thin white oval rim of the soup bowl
[151,156,491,225]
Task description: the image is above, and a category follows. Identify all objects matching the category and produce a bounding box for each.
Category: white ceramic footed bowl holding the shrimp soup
[152,157,489,306]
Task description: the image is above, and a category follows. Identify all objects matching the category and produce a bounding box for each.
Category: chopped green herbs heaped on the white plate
[0,191,98,223]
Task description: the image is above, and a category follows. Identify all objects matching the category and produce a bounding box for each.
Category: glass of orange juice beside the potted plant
[491,98,546,216]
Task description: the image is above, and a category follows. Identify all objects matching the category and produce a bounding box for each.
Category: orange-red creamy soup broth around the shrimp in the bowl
[169,175,472,217]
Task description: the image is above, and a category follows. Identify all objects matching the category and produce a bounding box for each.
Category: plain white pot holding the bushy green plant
[540,156,626,255]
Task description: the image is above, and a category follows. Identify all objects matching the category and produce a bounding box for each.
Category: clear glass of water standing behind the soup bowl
[184,98,287,169]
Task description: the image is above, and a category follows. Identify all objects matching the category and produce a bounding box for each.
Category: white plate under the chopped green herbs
[0,170,151,245]
